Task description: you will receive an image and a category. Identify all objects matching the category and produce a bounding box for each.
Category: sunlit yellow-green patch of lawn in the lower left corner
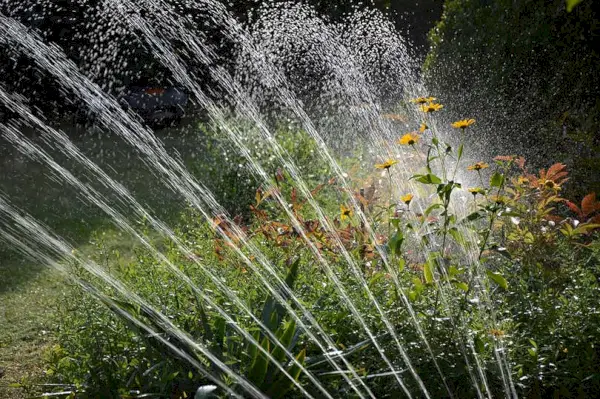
[0,227,159,399]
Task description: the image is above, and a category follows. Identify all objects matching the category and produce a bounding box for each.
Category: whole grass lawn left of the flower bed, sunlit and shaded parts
[0,120,204,399]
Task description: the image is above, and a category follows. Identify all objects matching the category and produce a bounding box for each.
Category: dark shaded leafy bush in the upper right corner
[424,0,600,196]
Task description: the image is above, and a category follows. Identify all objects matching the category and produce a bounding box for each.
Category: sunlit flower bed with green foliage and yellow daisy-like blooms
[35,99,600,398]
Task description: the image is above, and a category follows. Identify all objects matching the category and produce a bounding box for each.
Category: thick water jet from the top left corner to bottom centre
[0,21,372,397]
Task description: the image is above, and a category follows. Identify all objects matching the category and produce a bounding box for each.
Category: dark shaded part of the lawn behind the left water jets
[0,122,210,295]
